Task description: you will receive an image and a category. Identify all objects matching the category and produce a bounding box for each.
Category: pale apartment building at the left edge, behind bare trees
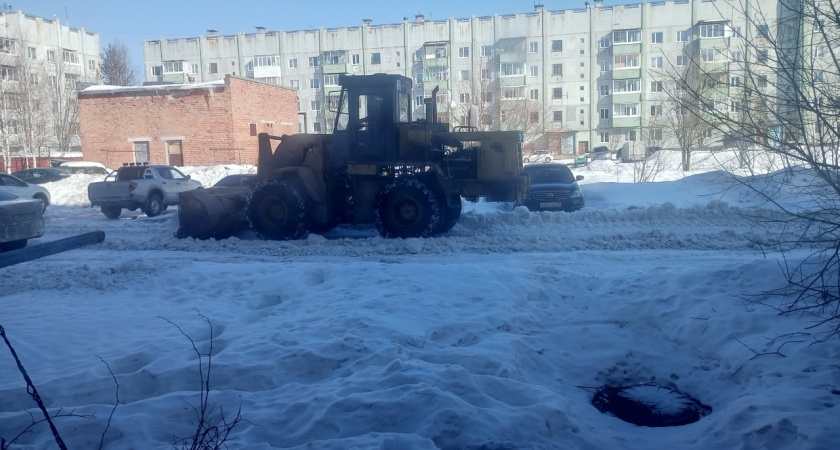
[0,11,100,165]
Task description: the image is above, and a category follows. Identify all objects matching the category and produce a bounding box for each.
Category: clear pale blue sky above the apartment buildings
[14,0,612,76]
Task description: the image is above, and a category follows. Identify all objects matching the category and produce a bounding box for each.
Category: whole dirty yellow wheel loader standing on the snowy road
[176,74,529,240]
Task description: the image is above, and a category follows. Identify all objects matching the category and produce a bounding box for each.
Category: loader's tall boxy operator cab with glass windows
[334,74,411,163]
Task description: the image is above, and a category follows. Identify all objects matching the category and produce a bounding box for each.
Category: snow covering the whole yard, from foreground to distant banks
[0,152,840,450]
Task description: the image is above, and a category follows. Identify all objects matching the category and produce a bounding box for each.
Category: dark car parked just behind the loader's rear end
[521,163,585,212]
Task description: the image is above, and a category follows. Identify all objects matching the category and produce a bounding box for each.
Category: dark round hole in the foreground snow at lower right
[592,383,712,427]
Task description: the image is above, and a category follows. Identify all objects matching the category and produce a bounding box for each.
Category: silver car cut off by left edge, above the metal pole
[0,189,44,252]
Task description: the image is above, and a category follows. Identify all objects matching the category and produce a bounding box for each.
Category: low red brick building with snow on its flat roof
[79,75,299,168]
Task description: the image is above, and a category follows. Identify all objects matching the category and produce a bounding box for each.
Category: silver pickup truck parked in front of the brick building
[88,165,202,219]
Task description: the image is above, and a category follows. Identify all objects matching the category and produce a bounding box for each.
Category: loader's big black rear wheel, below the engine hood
[373,178,442,238]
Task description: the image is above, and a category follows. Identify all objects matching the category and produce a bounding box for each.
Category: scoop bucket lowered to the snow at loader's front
[175,186,251,239]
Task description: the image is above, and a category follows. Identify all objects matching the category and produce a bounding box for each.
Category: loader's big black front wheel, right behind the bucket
[245,178,310,241]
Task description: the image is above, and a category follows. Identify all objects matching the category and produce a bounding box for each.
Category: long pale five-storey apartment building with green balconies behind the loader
[143,0,779,162]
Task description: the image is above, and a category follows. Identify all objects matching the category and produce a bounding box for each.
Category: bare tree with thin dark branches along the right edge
[684,0,840,340]
